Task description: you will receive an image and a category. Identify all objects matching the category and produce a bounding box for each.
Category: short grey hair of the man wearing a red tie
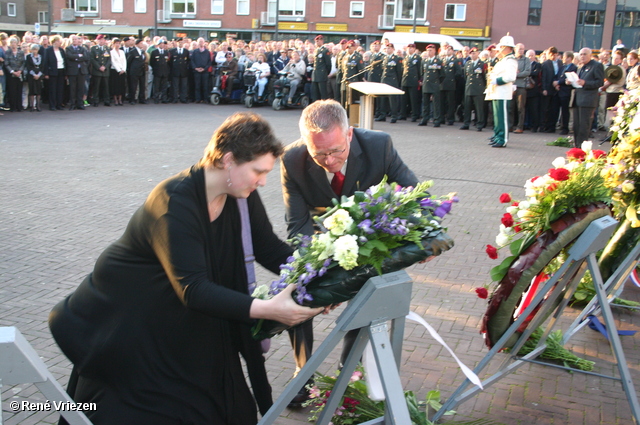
[299,99,349,143]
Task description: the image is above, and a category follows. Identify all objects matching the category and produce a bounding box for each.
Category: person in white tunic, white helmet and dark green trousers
[486,35,518,148]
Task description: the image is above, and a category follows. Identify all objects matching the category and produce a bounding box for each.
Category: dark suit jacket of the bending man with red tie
[280,129,418,237]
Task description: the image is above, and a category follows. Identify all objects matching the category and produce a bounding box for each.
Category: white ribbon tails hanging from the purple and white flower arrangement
[362,311,483,401]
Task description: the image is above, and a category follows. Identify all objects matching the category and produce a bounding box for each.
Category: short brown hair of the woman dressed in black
[200,112,283,168]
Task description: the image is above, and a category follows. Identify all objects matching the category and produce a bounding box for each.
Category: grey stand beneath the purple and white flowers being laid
[258,270,413,425]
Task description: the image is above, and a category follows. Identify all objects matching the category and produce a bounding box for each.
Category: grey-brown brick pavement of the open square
[0,104,640,425]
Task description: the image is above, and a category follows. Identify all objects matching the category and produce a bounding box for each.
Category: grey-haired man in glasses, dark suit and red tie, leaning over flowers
[280,100,418,407]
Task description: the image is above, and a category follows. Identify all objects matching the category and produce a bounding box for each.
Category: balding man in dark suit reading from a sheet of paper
[567,47,604,148]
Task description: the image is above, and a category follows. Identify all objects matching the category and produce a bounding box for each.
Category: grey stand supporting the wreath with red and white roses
[430,216,640,425]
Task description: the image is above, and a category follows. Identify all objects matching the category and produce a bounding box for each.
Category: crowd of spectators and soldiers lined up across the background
[0,29,640,144]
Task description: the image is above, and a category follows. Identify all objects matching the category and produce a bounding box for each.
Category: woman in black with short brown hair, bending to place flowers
[50,114,322,425]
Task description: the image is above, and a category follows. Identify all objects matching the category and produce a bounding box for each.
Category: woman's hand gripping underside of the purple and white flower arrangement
[249,285,324,326]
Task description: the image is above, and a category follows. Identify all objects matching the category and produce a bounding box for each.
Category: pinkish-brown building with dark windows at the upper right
[491,0,640,51]
